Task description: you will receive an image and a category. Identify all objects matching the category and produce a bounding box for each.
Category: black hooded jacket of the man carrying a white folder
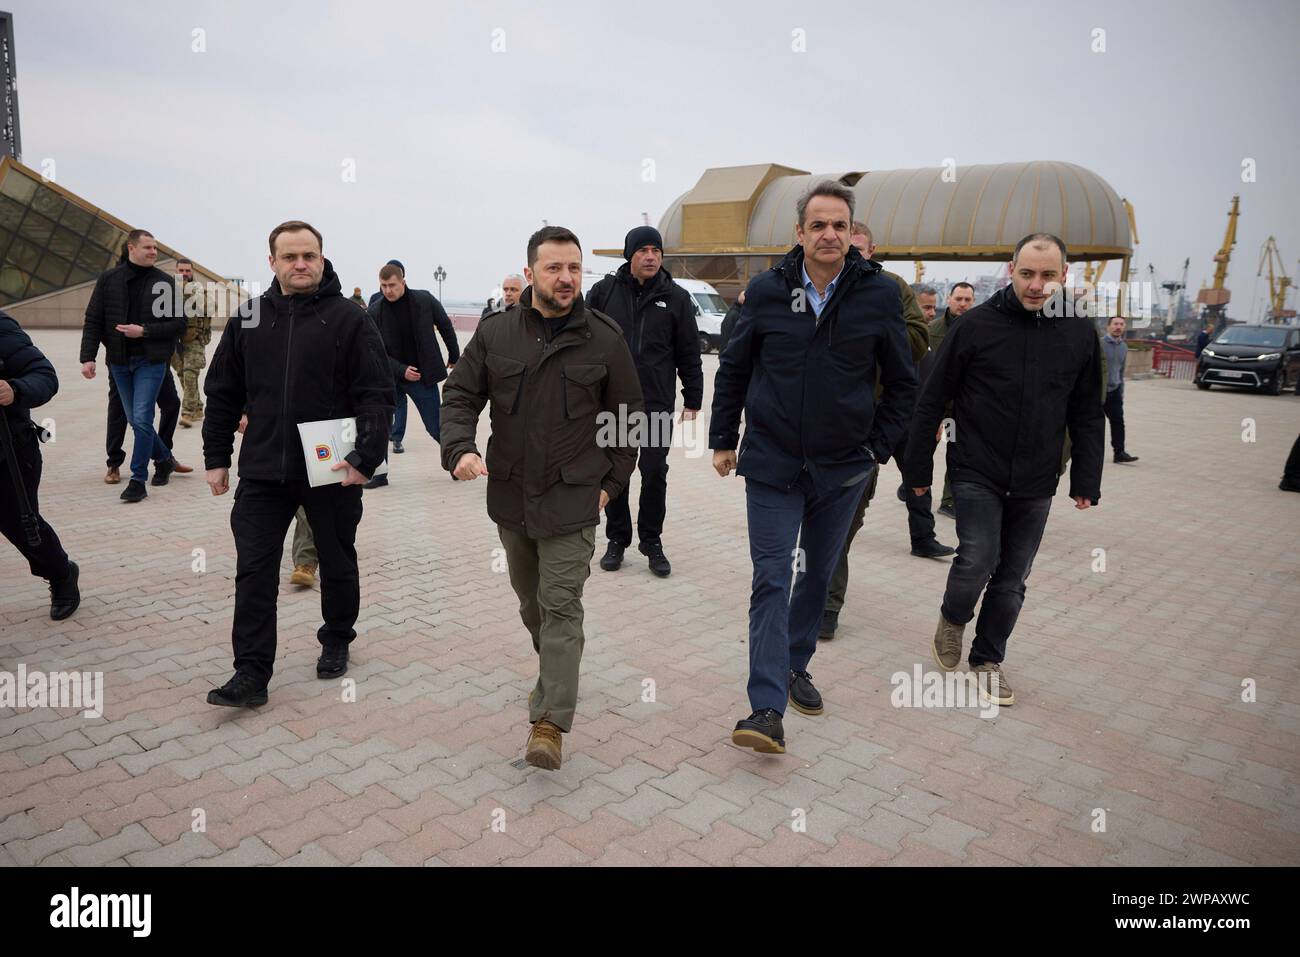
[203,259,394,481]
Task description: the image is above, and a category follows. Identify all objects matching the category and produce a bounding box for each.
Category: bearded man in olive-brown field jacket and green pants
[442,226,642,771]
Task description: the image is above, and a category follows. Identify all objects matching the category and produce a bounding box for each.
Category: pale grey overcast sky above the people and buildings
[8,0,1300,310]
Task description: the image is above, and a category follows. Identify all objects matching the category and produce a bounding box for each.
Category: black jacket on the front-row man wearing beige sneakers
[902,286,1105,503]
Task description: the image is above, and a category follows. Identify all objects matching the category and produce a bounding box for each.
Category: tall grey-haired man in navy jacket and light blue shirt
[709,181,917,754]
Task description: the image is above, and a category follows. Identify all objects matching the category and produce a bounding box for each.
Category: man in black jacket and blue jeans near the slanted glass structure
[81,229,186,502]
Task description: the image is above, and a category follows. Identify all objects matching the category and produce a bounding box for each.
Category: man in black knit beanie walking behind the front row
[586,226,705,579]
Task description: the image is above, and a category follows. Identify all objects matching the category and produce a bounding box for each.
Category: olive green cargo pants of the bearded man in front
[497,525,595,731]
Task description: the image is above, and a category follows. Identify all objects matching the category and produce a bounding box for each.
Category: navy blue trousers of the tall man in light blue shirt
[745,472,870,715]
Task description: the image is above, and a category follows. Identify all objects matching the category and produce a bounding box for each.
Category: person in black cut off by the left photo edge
[0,312,81,622]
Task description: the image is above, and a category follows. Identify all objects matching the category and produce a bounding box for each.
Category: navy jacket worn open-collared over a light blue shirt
[709,246,917,492]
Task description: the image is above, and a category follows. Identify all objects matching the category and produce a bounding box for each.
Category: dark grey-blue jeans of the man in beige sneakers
[941,482,1052,664]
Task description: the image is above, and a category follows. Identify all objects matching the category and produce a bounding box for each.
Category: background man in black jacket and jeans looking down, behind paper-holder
[365,263,460,489]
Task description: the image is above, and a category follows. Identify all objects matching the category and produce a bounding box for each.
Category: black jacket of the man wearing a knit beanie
[586,263,705,412]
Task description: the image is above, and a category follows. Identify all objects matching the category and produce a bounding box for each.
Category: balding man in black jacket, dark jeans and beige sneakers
[902,233,1105,705]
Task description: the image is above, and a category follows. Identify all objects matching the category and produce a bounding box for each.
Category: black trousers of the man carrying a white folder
[230,479,361,684]
